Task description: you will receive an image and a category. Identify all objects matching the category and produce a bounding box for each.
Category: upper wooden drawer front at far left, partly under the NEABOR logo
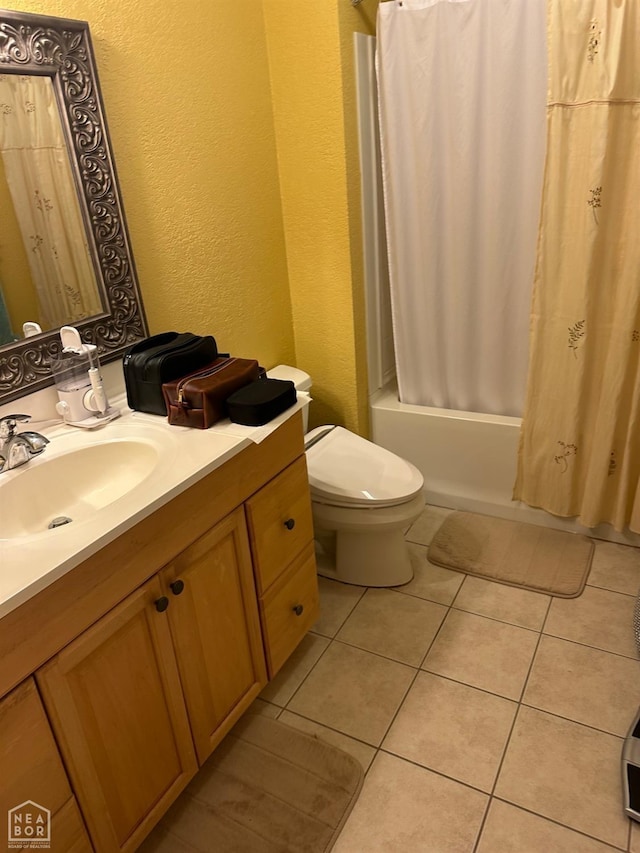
[0,678,71,850]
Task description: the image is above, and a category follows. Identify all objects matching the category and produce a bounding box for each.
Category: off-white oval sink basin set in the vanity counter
[0,437,163,539]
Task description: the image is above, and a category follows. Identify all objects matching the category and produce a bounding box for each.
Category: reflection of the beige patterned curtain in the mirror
[0,74,102,329]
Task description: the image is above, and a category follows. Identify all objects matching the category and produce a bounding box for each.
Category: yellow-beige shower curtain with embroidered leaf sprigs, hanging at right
[514,0,640,532]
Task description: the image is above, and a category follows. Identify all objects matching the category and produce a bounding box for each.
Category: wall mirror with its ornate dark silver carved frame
[0,10,148,403]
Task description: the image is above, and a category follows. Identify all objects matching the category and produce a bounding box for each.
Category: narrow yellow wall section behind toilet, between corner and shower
[263,0,375,434]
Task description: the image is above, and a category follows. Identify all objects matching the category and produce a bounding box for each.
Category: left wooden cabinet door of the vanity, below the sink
[37,578,197,853]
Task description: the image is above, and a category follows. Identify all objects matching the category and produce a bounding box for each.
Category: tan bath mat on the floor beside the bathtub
[429,512,594,598]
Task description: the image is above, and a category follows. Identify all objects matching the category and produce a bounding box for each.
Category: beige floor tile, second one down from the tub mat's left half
[422,610,540,701]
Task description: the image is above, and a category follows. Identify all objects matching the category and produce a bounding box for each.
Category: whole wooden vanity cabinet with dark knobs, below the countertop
[0,414,318,853]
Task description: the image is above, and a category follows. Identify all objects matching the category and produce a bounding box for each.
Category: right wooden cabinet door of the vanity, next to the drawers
[161,509,266,763]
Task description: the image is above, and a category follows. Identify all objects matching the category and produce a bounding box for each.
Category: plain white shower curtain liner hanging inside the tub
[376,0,547,415]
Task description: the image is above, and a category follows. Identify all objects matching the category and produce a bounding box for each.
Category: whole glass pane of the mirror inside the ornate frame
[0,74,104,344]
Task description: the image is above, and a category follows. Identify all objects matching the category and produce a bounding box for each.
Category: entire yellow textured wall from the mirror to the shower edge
[6,0,376,434]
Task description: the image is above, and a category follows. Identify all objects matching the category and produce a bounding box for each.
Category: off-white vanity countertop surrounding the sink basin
[0,394,309,618]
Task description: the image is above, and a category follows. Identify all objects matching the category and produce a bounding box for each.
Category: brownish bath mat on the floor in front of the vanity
[140,714,364,853]
